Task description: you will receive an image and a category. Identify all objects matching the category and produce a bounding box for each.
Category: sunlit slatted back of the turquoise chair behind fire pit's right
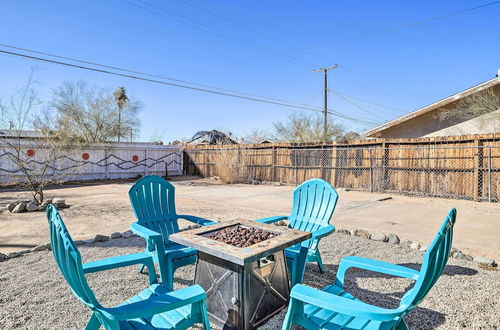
[289,179,338,232]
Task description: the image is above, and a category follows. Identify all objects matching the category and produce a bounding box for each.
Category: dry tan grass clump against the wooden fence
[213,146,249,183]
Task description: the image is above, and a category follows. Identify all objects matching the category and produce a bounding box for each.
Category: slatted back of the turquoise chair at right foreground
[401,209,457,312]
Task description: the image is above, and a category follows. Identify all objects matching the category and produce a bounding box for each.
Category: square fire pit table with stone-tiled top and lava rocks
[169,220,311,329]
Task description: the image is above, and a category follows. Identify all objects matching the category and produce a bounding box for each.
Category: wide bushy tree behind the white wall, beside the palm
[52,81,141,143]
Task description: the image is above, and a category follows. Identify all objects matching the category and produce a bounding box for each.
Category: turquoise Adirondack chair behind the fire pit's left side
[128,175,216,289]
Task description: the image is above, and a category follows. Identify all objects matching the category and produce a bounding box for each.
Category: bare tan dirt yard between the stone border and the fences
[0,178,500,261]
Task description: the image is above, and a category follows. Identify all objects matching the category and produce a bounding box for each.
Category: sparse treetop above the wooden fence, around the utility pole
[273,113,344,142]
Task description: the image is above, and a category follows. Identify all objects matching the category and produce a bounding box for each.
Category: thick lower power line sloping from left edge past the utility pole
[0,49,378,125]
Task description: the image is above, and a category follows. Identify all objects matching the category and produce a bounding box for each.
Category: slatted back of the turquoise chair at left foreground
[47,205,101,310]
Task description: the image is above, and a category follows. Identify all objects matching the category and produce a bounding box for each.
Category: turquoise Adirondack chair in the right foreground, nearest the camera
[283,209,456,330]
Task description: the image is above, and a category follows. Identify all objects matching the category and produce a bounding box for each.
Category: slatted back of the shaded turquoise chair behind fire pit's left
[128,175,179,244]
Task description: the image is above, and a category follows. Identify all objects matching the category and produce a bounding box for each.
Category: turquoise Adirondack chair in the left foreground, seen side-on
[47,205,210,330]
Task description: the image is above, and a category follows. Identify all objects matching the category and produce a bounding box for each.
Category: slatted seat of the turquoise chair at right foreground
[304,284,390,329]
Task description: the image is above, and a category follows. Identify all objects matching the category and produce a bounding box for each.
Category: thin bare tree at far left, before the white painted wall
[0,71,67,204]
